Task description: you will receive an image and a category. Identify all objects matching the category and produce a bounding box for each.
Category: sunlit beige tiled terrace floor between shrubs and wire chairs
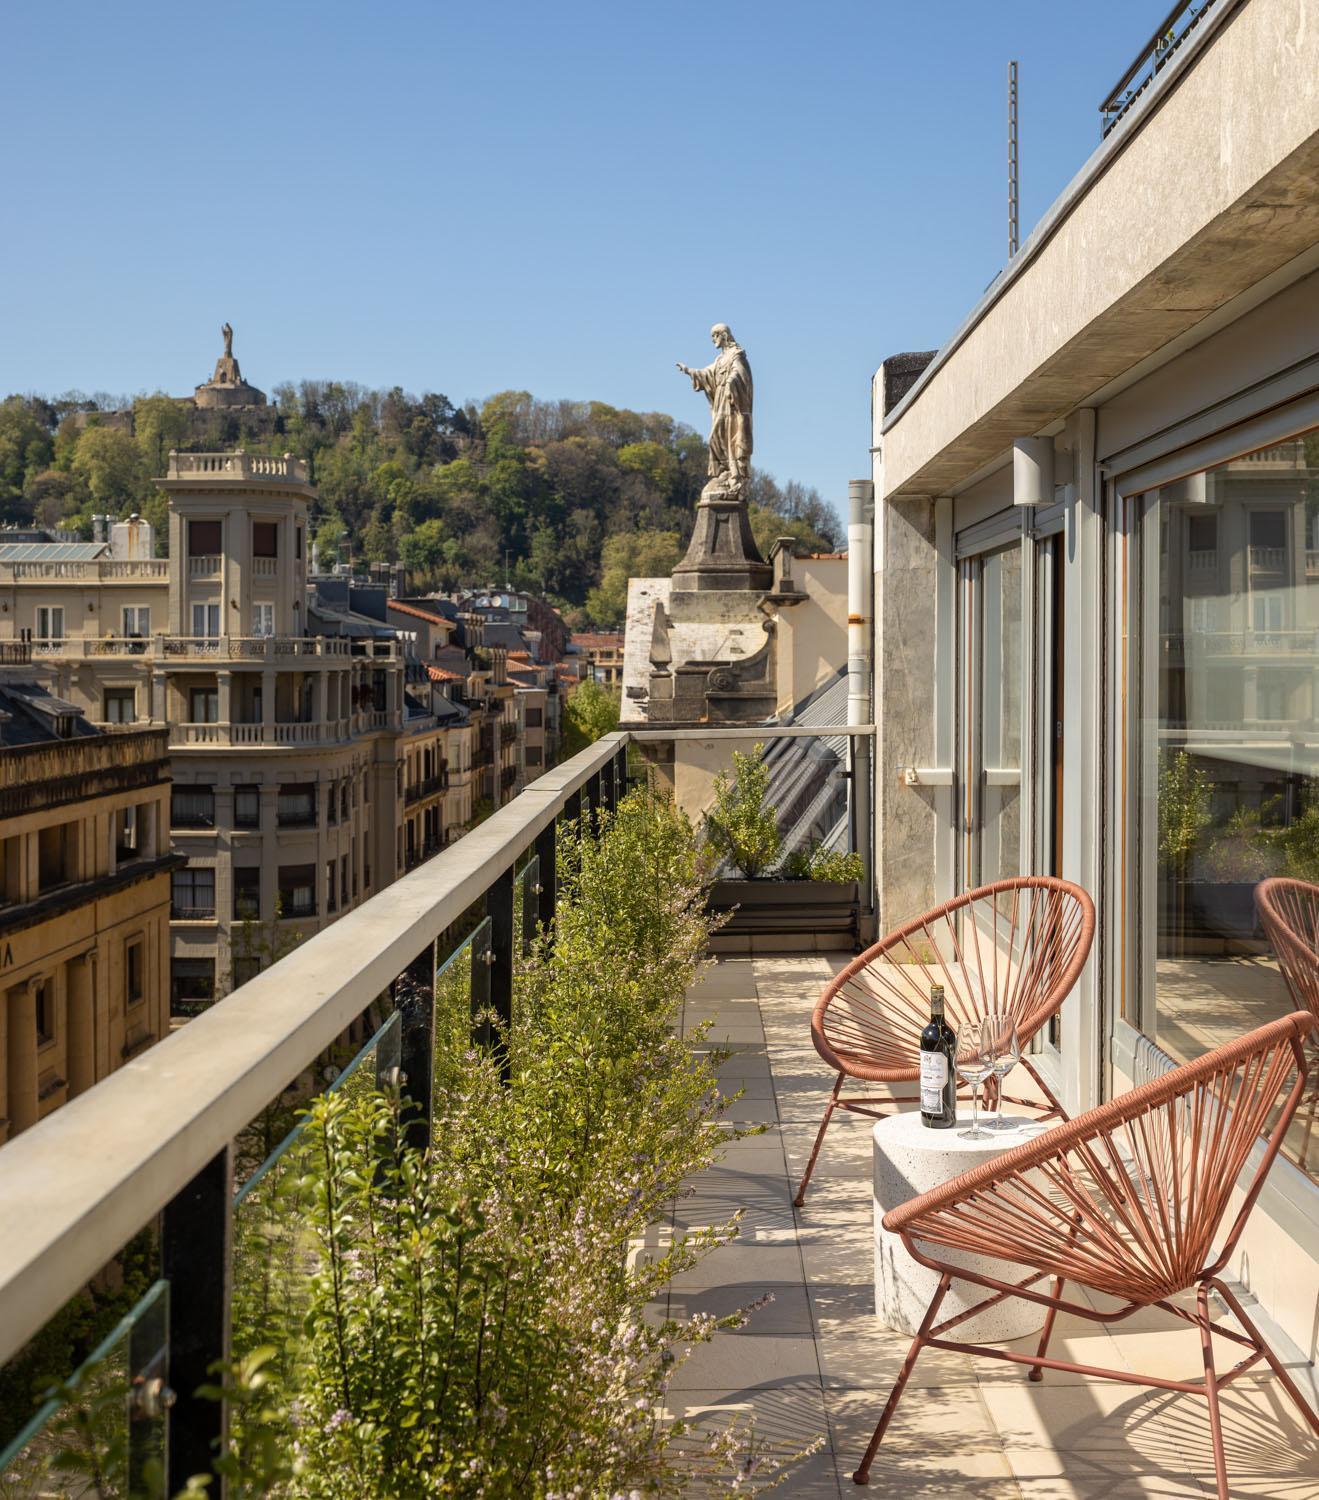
[657,956,1319,1500]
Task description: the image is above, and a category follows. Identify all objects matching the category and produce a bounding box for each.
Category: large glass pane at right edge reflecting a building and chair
[1119,434,1319,1181]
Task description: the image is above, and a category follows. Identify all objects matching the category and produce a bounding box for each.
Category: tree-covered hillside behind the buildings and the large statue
[0,381,839,627]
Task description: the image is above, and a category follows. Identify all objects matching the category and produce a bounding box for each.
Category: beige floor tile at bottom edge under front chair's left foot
[824,1383,1019,1500]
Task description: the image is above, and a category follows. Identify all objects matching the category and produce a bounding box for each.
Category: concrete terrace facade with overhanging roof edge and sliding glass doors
[870,0,1319,1359]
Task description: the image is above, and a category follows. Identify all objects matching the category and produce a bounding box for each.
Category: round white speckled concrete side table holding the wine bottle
[873,1110,1047,1344]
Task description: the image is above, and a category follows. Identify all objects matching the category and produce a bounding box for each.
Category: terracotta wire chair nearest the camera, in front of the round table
[852,1011,1319,1500]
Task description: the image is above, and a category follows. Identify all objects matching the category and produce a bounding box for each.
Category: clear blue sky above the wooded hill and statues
[0,0,1163,516]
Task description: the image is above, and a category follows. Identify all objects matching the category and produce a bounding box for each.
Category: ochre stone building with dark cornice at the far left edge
[0,687,179,1142]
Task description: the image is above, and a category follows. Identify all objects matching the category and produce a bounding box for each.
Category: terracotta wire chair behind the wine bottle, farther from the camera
[794,875,1094,1208]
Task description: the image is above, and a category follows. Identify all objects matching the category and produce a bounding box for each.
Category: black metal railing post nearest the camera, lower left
[161,1146,234,1500]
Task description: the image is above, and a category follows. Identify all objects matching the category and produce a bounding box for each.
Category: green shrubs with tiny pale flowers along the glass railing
[216,791,804,1500]
